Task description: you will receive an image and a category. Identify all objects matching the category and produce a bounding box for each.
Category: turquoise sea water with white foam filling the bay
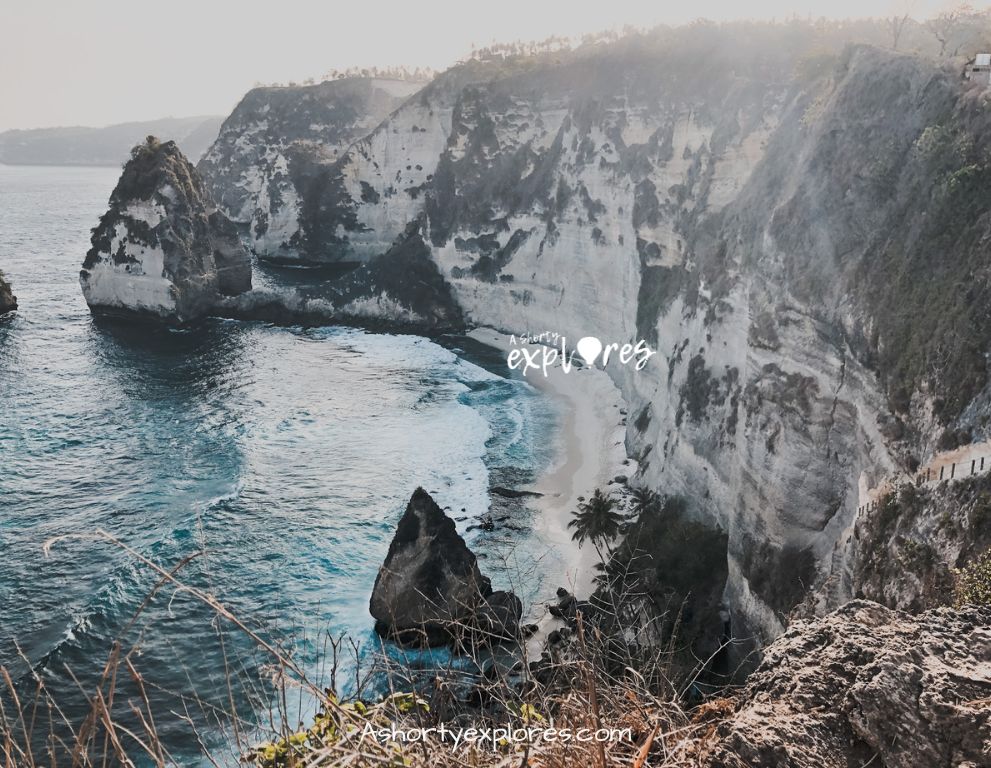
[0,166,556,762]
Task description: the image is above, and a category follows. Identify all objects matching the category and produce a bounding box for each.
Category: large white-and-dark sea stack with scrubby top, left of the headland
[79,136,251,324]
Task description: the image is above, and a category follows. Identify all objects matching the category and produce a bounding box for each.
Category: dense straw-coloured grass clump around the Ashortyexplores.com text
[240,618,726,768]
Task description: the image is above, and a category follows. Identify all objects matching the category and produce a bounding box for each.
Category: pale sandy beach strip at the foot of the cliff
[466,328,636,600]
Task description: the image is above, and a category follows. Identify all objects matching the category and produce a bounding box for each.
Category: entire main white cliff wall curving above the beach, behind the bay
[198,36,991,644]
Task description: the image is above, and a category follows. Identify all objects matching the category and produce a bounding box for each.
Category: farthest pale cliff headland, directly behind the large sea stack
[198,77,422,262]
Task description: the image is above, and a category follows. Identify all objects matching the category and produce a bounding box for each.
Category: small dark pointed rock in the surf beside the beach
[369,488,523,645]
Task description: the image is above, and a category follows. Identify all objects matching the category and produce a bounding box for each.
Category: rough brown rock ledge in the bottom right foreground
[700,600,991,768]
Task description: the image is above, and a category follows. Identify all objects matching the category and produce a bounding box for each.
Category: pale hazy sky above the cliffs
[0,0,941,130]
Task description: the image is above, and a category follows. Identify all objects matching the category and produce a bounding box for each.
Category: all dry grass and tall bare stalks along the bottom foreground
[0,531,728,768]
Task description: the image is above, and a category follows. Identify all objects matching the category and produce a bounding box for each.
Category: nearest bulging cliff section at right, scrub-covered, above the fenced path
[627,48,991,642]
